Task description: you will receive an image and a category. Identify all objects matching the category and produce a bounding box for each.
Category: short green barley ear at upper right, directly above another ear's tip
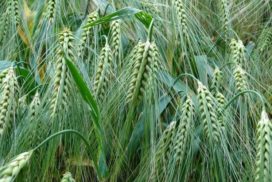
[230,39,245,64]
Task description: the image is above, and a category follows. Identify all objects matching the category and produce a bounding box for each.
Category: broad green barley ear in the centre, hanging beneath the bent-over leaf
[127,41,159,103]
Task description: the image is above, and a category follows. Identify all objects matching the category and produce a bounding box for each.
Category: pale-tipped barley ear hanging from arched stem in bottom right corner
[255,111,272,182]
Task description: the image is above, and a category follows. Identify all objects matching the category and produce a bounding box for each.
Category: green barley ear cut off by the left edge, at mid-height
[0,68,18,136]
